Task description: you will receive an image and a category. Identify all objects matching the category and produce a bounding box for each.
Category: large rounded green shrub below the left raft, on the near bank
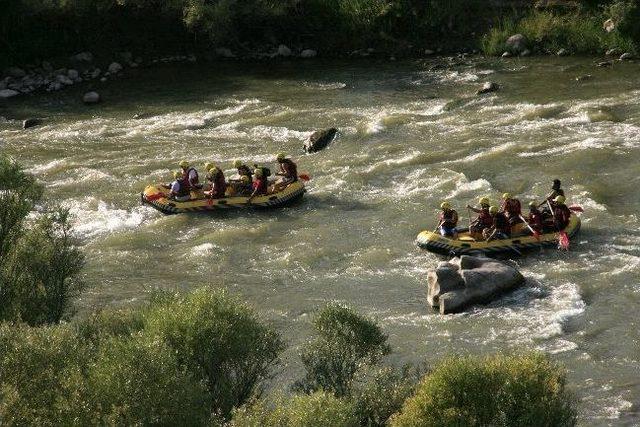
[145,288,283,416]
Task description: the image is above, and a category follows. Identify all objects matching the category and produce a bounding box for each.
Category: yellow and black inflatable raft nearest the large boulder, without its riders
[416,215,580,255]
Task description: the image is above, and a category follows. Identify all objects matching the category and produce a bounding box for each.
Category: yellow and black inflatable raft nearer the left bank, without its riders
[140,181,306,214]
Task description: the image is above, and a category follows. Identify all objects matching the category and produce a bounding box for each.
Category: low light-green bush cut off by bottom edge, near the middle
[231,391,360,427]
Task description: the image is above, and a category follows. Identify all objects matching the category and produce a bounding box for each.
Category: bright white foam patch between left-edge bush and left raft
[63,197,151,239]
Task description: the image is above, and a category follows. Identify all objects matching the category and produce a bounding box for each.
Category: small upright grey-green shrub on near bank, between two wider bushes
[295,304,390,396]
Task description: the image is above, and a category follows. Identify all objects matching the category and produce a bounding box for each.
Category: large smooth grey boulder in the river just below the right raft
[427,255,524,314]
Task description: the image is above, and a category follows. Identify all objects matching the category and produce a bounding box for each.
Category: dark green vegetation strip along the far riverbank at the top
[0,0,640,66]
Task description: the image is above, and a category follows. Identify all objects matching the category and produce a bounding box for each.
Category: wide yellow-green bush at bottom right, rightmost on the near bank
[391,353,576,427]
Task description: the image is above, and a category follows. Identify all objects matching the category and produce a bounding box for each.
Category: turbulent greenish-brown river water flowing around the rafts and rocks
[0,58,640,425]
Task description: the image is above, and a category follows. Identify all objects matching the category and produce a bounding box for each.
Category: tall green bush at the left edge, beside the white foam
[0,157,84,325]
